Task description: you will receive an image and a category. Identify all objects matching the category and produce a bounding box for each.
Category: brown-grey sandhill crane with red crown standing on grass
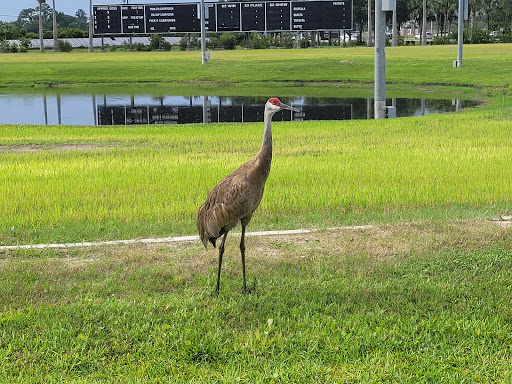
[197,97,298,295]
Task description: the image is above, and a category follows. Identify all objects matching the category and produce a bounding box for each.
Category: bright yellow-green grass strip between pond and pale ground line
[0,99,512,244]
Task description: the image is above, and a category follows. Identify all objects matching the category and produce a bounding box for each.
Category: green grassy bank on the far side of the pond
[0,44,512,87]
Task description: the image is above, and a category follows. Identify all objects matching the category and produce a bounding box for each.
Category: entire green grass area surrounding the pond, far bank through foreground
[0,44,512,383]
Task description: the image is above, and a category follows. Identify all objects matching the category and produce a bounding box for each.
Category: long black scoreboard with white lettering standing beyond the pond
[93,0,352,35]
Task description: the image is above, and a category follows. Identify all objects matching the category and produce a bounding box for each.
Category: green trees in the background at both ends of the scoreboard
[0,0,512,43]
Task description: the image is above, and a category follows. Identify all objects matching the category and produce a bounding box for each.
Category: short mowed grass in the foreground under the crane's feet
[0,220,512,383]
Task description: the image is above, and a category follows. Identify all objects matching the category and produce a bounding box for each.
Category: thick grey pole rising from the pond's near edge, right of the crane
[374,0,386,119]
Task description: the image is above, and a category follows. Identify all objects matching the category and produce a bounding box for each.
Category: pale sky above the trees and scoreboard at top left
[0,0,199,22]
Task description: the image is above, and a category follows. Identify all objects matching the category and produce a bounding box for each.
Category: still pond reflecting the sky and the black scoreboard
[0,90,479,125]
